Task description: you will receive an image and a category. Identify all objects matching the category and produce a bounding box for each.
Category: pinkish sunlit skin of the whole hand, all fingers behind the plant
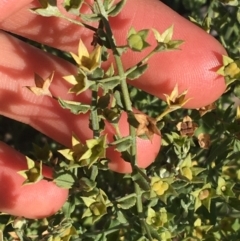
[0,0,226,218]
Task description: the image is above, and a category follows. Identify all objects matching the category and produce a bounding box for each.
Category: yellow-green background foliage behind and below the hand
[0,0,240,241]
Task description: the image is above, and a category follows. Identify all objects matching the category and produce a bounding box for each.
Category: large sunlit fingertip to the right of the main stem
[111,0,227,108]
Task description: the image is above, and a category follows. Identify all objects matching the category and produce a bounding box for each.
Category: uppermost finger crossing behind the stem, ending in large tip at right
[0,0,226,108]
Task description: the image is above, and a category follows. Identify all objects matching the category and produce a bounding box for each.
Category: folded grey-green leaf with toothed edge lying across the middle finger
[58,98,91,115]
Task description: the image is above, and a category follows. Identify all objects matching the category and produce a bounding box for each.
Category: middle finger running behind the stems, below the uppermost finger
[0,33,161,172]
